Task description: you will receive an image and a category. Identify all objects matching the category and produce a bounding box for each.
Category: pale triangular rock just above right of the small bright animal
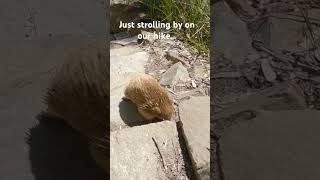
[160,62,189,86]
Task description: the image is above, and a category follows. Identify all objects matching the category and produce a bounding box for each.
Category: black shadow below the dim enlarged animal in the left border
[27,113,106,180]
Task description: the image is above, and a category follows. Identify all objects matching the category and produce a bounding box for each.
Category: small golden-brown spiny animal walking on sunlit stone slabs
[124,74,174,120]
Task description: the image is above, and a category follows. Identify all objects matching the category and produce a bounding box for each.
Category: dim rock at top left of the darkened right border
[211,1,251,65]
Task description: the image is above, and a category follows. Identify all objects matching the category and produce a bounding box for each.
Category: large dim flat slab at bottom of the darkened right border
[219,110,320,180]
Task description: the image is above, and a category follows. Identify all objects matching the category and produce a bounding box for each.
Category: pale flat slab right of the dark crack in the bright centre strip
[179,96,210,180]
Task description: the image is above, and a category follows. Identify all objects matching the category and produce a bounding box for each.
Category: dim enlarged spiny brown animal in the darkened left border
[45,41,109,172]
